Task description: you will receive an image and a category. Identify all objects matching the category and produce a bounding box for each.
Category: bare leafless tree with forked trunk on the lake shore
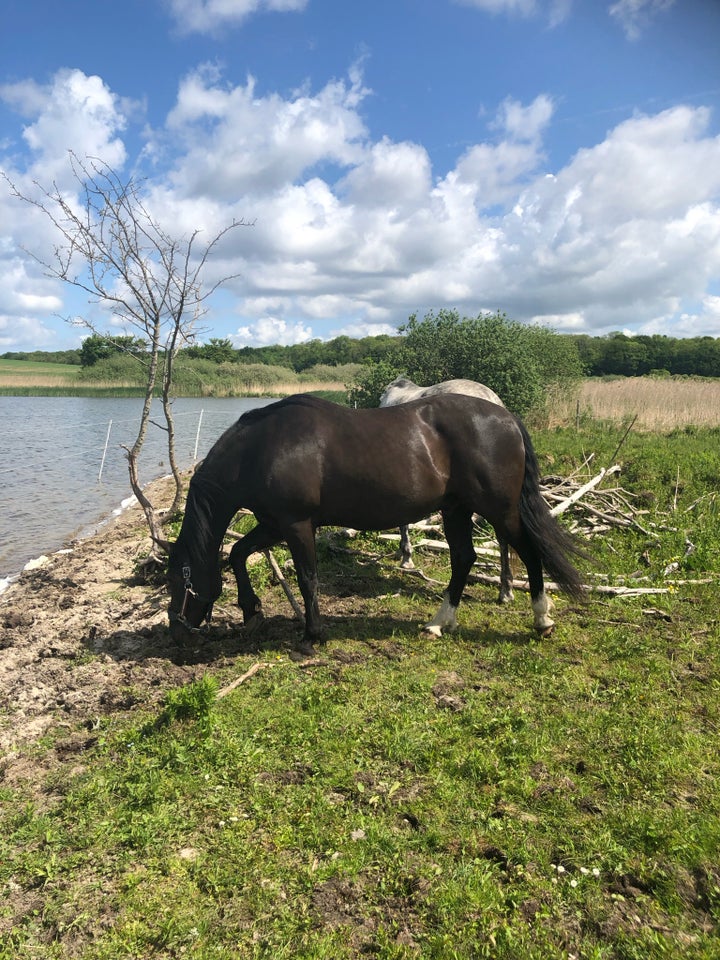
[2,152,249,559]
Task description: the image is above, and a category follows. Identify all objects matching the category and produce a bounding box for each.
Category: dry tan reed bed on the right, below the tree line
[548,377,720,432]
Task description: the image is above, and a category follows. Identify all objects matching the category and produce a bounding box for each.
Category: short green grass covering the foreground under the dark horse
[0,428,720,960]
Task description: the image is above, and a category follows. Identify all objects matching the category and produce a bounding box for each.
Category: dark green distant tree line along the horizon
[5,328,720,380]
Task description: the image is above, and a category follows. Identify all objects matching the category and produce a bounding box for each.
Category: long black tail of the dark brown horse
[517,420,589,598]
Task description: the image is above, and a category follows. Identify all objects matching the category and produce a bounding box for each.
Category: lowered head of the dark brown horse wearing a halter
[168,544,222,643]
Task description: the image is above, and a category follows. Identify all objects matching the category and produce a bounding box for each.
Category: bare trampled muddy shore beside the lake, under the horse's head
[0,481,306,776]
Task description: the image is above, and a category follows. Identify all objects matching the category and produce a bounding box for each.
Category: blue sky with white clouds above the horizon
[0,0,720,353]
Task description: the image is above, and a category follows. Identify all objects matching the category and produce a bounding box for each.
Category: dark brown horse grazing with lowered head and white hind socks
[168,394,583,646]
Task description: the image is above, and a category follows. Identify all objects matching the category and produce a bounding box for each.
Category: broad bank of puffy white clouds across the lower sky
[0,62,720,349]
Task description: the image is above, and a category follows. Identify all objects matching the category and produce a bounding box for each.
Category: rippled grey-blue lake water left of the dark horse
[0,397,272,589]
